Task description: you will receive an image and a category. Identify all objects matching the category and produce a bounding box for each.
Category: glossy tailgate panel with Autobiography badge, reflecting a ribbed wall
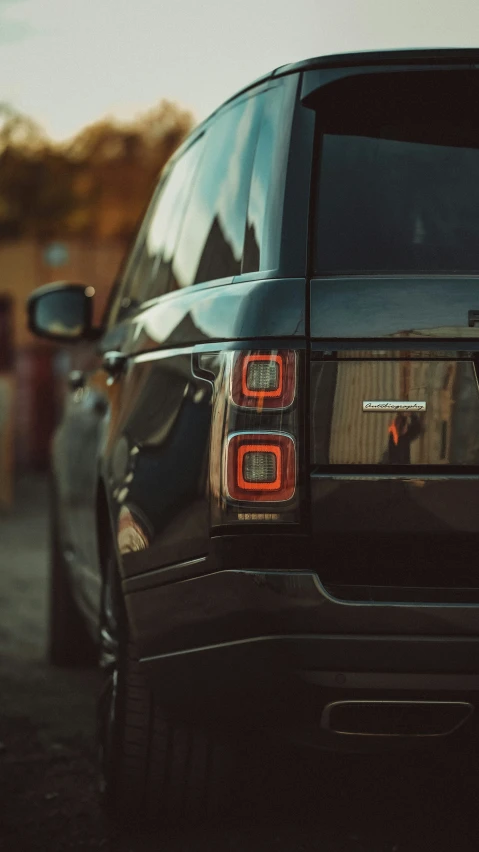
[311,350,479,466]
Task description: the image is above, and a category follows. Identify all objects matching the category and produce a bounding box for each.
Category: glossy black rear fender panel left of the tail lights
[109,352,212,576]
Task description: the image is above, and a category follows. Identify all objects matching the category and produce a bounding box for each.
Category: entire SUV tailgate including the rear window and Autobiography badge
[310,69,479,600]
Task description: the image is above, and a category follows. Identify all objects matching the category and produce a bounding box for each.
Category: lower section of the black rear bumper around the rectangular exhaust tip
[143,635,479,751]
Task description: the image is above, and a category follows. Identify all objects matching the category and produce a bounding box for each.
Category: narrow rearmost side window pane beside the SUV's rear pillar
[241,83,289,272]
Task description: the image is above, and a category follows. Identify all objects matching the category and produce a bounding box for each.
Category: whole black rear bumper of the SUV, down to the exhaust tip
[126,544,479,748]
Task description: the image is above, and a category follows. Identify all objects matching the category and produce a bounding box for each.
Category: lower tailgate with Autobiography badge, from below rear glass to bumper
[310,279,479,602]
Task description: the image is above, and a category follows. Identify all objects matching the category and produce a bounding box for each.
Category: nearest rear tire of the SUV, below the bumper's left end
[98,548,232,828]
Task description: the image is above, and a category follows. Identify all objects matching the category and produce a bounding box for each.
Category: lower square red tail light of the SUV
[226,433,296,503]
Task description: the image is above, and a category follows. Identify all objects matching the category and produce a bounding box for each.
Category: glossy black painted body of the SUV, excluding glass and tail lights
[34,51,479,747]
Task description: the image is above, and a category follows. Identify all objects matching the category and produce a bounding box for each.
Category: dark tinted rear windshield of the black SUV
[314,71,479,275]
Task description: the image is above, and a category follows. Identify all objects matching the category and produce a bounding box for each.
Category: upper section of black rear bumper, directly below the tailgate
[125,563,479,673]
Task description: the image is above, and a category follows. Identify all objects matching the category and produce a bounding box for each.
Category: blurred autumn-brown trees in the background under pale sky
[0,101,194,239]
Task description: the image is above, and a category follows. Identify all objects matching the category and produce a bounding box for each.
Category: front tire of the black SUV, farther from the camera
[48,486,98,667]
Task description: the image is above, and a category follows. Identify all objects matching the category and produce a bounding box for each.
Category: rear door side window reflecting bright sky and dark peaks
[172,94,263,288]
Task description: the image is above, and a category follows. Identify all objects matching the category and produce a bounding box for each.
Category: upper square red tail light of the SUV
[231,351,296,409]
